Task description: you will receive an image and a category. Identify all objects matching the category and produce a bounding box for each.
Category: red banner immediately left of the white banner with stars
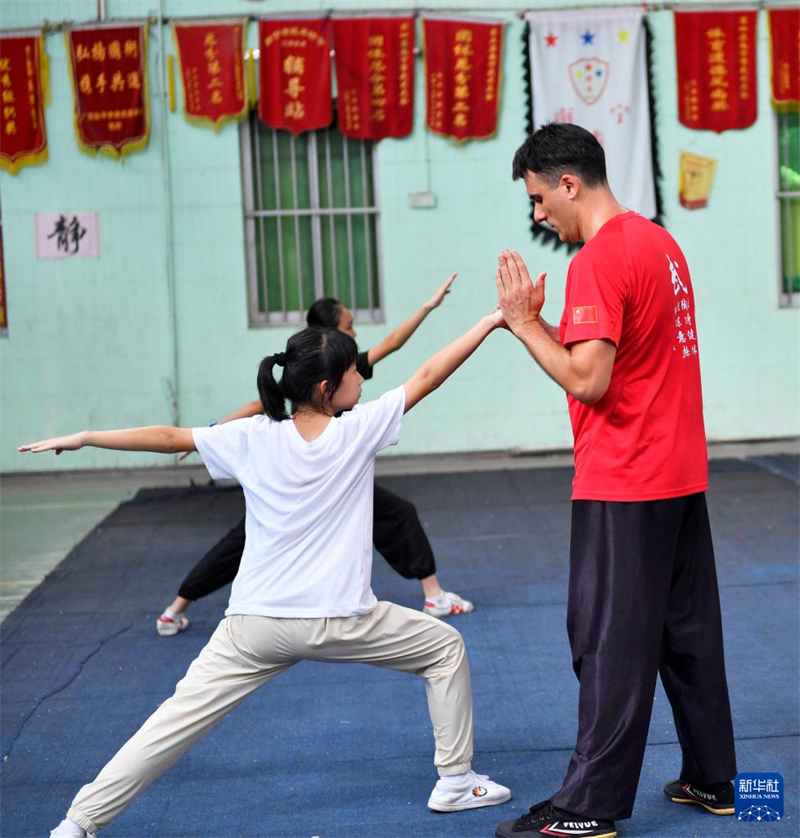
[422,18,503,140]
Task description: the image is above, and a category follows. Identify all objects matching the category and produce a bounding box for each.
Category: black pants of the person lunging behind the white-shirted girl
[178,484,436,601]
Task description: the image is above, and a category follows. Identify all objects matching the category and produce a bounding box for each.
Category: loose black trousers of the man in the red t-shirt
[551,493,736,820]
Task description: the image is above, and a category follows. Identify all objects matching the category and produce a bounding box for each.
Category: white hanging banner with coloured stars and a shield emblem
[525,8,658,237]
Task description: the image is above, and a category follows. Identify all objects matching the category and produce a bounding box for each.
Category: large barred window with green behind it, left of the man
[241,111,382,326]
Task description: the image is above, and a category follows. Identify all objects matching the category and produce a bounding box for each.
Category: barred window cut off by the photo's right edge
[777,113,800,306]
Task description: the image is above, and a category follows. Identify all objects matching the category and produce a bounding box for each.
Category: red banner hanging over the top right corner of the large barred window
[333,17,414,140]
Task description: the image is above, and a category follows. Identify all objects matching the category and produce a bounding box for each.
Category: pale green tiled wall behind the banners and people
[0,0,800,471]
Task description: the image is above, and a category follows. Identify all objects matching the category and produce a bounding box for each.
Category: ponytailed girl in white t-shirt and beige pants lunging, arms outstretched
[25,311,511,838]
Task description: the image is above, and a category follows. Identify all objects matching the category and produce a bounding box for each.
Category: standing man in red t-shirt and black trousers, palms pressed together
[495,123,736,838]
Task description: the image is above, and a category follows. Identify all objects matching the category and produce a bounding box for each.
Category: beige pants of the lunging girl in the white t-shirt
[67,602,472,832]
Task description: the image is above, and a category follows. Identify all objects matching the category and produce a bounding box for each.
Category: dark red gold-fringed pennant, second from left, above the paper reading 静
[65,24,150,157]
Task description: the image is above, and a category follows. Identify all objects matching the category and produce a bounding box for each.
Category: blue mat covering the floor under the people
[0,457,800,838]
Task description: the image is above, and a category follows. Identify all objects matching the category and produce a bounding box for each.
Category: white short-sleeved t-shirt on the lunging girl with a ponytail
[192,387,406,617]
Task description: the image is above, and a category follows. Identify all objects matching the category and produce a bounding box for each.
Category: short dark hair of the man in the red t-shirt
[511,122,608,186]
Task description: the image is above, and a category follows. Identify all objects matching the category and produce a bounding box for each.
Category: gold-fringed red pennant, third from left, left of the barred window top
[172,20,247,131]
